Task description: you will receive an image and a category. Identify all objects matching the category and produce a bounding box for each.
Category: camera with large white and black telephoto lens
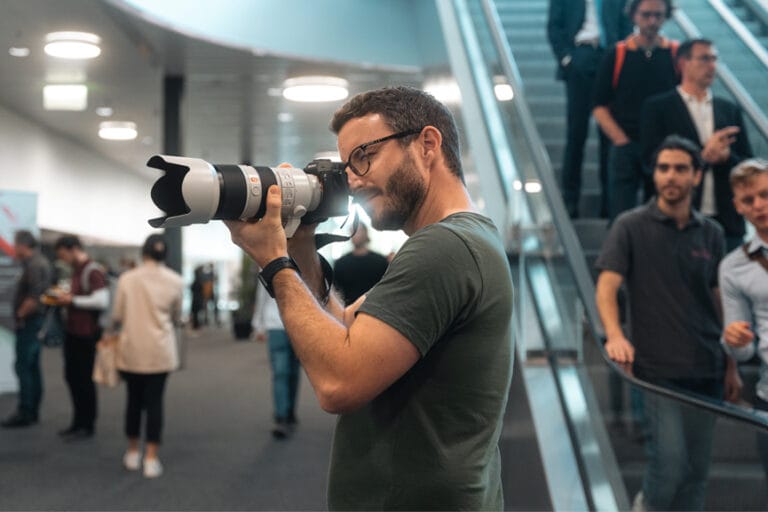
[147,155,349,237]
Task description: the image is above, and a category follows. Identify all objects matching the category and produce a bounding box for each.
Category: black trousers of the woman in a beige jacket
[120,371,168,444]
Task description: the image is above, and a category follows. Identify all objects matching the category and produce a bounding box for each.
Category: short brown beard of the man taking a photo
[371,155,427,230]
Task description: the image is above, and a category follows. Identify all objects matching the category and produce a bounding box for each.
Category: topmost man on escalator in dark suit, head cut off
[547,0,632,217]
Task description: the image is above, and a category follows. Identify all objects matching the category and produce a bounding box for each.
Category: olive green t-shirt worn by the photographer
[328,212,513,510]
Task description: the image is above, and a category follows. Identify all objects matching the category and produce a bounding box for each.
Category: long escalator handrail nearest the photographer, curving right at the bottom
[482,0,768,429]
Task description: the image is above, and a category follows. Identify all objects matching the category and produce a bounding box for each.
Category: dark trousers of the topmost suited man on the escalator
[560,46,610,217]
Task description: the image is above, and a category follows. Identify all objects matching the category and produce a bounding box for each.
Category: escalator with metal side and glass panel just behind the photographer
[438,0,768,510]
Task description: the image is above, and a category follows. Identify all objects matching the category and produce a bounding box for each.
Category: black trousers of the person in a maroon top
[64,333,100,430]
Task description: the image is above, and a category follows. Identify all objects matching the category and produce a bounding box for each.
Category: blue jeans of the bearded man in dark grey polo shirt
[643,381,722,510]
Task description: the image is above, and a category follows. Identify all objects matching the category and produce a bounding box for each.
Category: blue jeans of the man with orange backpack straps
[608,141,645,222]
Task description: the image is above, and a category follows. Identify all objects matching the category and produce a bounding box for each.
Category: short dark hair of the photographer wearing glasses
[331,86,464,181]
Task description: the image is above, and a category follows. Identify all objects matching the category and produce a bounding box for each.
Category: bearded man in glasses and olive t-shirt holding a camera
[227,87,513,510]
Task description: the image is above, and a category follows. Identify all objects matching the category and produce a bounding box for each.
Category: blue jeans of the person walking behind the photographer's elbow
[267,329,300,421]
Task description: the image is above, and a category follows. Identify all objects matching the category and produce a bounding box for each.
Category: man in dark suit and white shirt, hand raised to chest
[641,39,752,251]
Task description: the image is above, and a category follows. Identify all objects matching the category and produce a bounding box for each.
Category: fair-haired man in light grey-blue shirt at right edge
[720,159,768,474]
